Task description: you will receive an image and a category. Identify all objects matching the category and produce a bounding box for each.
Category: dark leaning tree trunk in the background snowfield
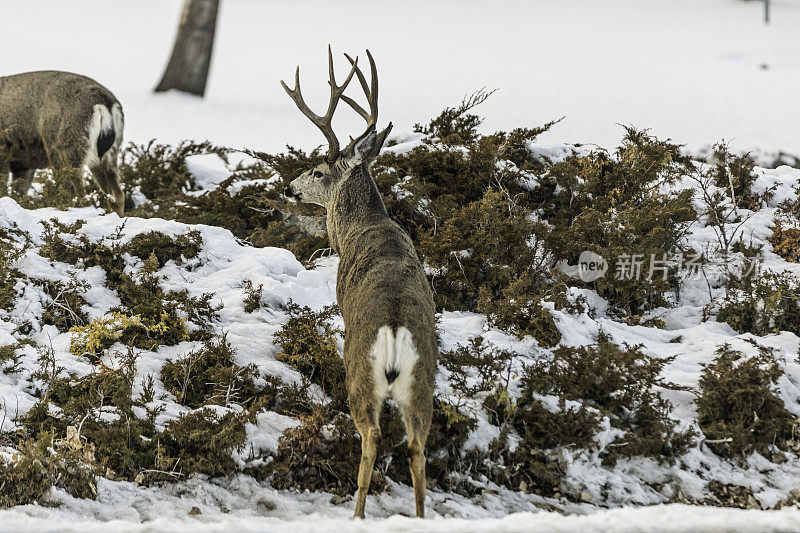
[155,0,219,96]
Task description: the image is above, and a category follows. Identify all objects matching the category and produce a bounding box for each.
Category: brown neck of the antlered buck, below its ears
[327,165,389,255]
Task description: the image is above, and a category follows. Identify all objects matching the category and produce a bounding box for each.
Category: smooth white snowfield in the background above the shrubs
[0,0,800,154]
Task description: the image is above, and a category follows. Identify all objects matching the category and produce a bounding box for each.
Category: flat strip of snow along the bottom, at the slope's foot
[3,493,800,533]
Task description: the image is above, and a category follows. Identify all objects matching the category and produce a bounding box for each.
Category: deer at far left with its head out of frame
[0,71,125,215]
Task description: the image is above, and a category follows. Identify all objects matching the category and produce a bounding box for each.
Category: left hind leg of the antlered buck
[350,388,382,518]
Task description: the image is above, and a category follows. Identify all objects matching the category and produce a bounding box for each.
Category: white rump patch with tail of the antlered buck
[370,326,419,407]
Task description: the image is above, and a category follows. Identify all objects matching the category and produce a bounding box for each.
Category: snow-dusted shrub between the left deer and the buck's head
[120,141,328,260]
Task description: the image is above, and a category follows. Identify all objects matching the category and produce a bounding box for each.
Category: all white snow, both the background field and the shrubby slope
[0,0,800,533]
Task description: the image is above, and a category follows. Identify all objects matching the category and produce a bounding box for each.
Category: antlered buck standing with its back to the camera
[281,46,438,518]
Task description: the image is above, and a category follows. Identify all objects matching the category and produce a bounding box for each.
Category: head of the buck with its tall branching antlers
[281,46,392,207]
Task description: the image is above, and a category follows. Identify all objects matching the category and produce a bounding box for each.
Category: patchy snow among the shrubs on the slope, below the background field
[0,155,800,531]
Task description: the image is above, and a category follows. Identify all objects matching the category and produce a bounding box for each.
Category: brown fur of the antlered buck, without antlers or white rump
[287,126,438,517]
